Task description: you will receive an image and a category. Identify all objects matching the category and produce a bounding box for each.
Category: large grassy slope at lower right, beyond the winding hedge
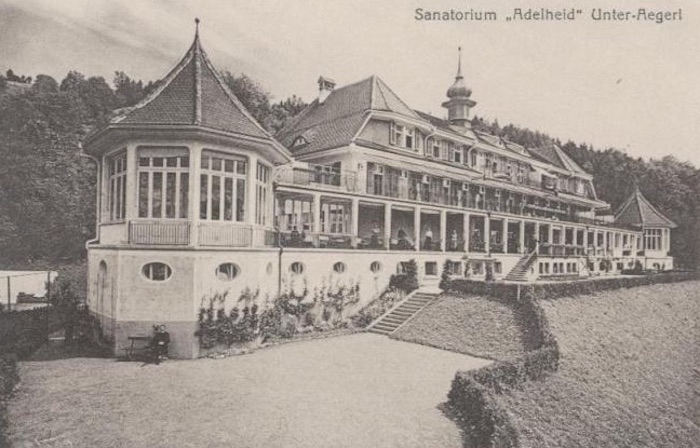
[499,282,700,448]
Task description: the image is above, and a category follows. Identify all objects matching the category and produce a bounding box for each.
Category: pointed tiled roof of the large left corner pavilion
[111,30,271,139]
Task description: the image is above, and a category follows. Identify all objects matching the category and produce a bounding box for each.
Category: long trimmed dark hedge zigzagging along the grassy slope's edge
[446,272,700,448]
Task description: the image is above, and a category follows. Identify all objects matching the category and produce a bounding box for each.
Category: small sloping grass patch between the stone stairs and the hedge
[392,295,528,360]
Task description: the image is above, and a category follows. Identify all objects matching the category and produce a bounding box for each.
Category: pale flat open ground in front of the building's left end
[9,334,488,448]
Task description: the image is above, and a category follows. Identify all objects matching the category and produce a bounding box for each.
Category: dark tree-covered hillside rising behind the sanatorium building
[0,71,700,267]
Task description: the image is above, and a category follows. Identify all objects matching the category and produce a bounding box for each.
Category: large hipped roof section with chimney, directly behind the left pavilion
[276,76,419,152]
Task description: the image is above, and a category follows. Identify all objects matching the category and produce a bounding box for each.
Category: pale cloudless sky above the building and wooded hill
[0,0,700,167]
